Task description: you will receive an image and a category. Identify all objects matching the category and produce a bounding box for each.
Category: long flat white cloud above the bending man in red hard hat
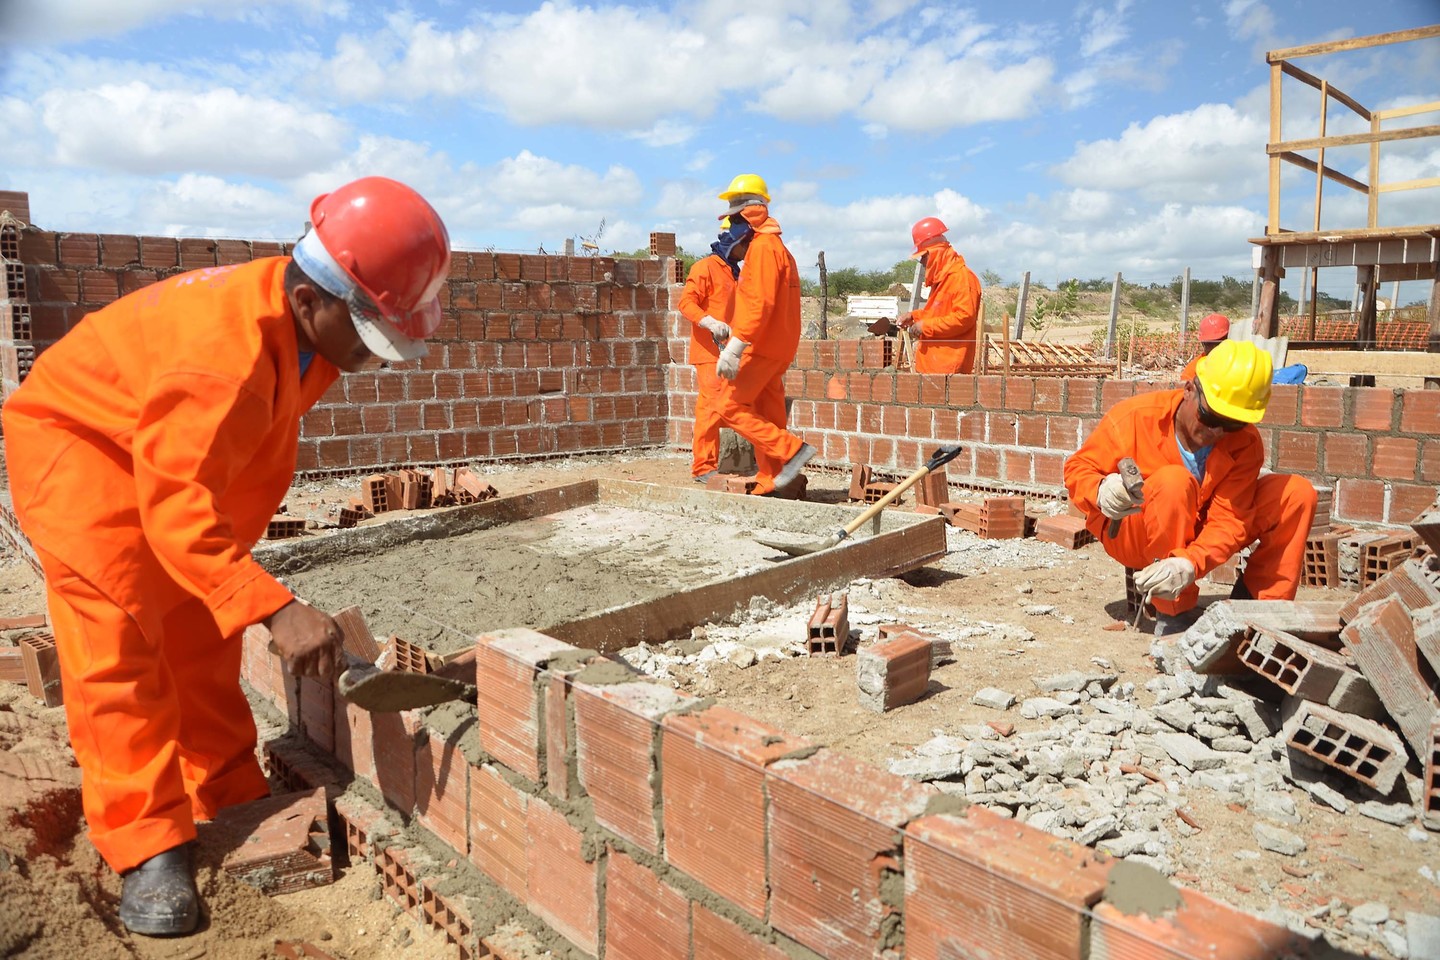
[40,81,348,177]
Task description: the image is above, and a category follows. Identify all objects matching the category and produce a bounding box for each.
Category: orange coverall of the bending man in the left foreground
[3,258,338,871]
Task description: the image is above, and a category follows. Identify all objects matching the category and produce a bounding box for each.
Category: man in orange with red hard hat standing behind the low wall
[896,217,981,374]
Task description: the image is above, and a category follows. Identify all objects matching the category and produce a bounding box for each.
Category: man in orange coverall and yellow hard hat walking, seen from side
[716,174,815,497]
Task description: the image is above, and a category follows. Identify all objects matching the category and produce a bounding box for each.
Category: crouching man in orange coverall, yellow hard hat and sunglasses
[1064,340,1316,636]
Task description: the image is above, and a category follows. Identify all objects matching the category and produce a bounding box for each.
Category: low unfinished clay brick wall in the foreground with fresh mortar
[243,628,1296,960]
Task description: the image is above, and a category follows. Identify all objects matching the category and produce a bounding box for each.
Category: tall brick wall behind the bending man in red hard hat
[0,193,677,472]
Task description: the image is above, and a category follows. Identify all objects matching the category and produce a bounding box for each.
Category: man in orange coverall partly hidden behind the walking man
[680,217,753,484]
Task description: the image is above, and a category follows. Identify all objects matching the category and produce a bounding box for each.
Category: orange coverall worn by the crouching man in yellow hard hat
[1064,390,1316,613]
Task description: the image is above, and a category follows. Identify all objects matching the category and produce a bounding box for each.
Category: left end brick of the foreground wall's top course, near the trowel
[475,630,576,783]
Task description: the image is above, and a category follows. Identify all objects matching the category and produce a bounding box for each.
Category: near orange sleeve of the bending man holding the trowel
[134,371,294,636]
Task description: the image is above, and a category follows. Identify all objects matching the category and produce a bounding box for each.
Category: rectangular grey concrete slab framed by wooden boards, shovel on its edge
[255,479,946,652]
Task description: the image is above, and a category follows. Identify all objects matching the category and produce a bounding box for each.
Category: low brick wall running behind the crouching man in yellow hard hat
[668,325,1440,524]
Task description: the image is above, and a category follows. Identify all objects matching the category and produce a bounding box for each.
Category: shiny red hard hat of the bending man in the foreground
[294,177,449,360]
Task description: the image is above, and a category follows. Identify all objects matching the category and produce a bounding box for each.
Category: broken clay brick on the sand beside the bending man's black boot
[207,789,336,895]
